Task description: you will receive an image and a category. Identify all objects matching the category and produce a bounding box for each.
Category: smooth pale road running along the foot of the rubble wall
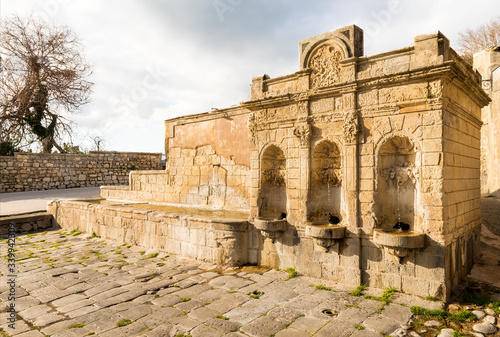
[0,187,101,215]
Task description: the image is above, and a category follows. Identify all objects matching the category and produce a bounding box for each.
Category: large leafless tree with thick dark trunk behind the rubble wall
[0,16,93,153]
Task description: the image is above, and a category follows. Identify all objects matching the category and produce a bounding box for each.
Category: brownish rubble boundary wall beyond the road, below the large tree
[0,152,161,193]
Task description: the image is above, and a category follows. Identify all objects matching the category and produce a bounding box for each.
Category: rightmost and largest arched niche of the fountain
[375,136,420,231]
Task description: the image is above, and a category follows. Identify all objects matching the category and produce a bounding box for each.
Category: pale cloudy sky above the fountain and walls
[0,0,500,152]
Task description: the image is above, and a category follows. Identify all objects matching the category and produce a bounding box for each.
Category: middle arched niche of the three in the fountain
[308,140,342,224]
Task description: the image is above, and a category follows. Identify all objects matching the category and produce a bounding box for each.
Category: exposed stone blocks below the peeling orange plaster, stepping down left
[101,145,250,210]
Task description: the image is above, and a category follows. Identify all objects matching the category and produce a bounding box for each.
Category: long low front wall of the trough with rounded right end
[47,200,248,266]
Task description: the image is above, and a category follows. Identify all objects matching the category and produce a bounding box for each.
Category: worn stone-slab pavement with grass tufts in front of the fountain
[0,230,442,337]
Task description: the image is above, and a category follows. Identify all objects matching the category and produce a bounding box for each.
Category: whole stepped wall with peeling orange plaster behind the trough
[101,114,251,211]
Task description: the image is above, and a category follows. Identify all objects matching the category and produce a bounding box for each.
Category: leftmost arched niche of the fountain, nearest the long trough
[257,145,287,219]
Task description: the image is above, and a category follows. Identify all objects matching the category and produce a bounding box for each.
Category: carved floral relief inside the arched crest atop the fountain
[309,45,342,89]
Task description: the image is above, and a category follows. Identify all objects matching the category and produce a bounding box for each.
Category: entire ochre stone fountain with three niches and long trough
[49,25,489,299]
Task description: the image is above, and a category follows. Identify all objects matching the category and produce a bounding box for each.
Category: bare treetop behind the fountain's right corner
[458,17,500,61]
